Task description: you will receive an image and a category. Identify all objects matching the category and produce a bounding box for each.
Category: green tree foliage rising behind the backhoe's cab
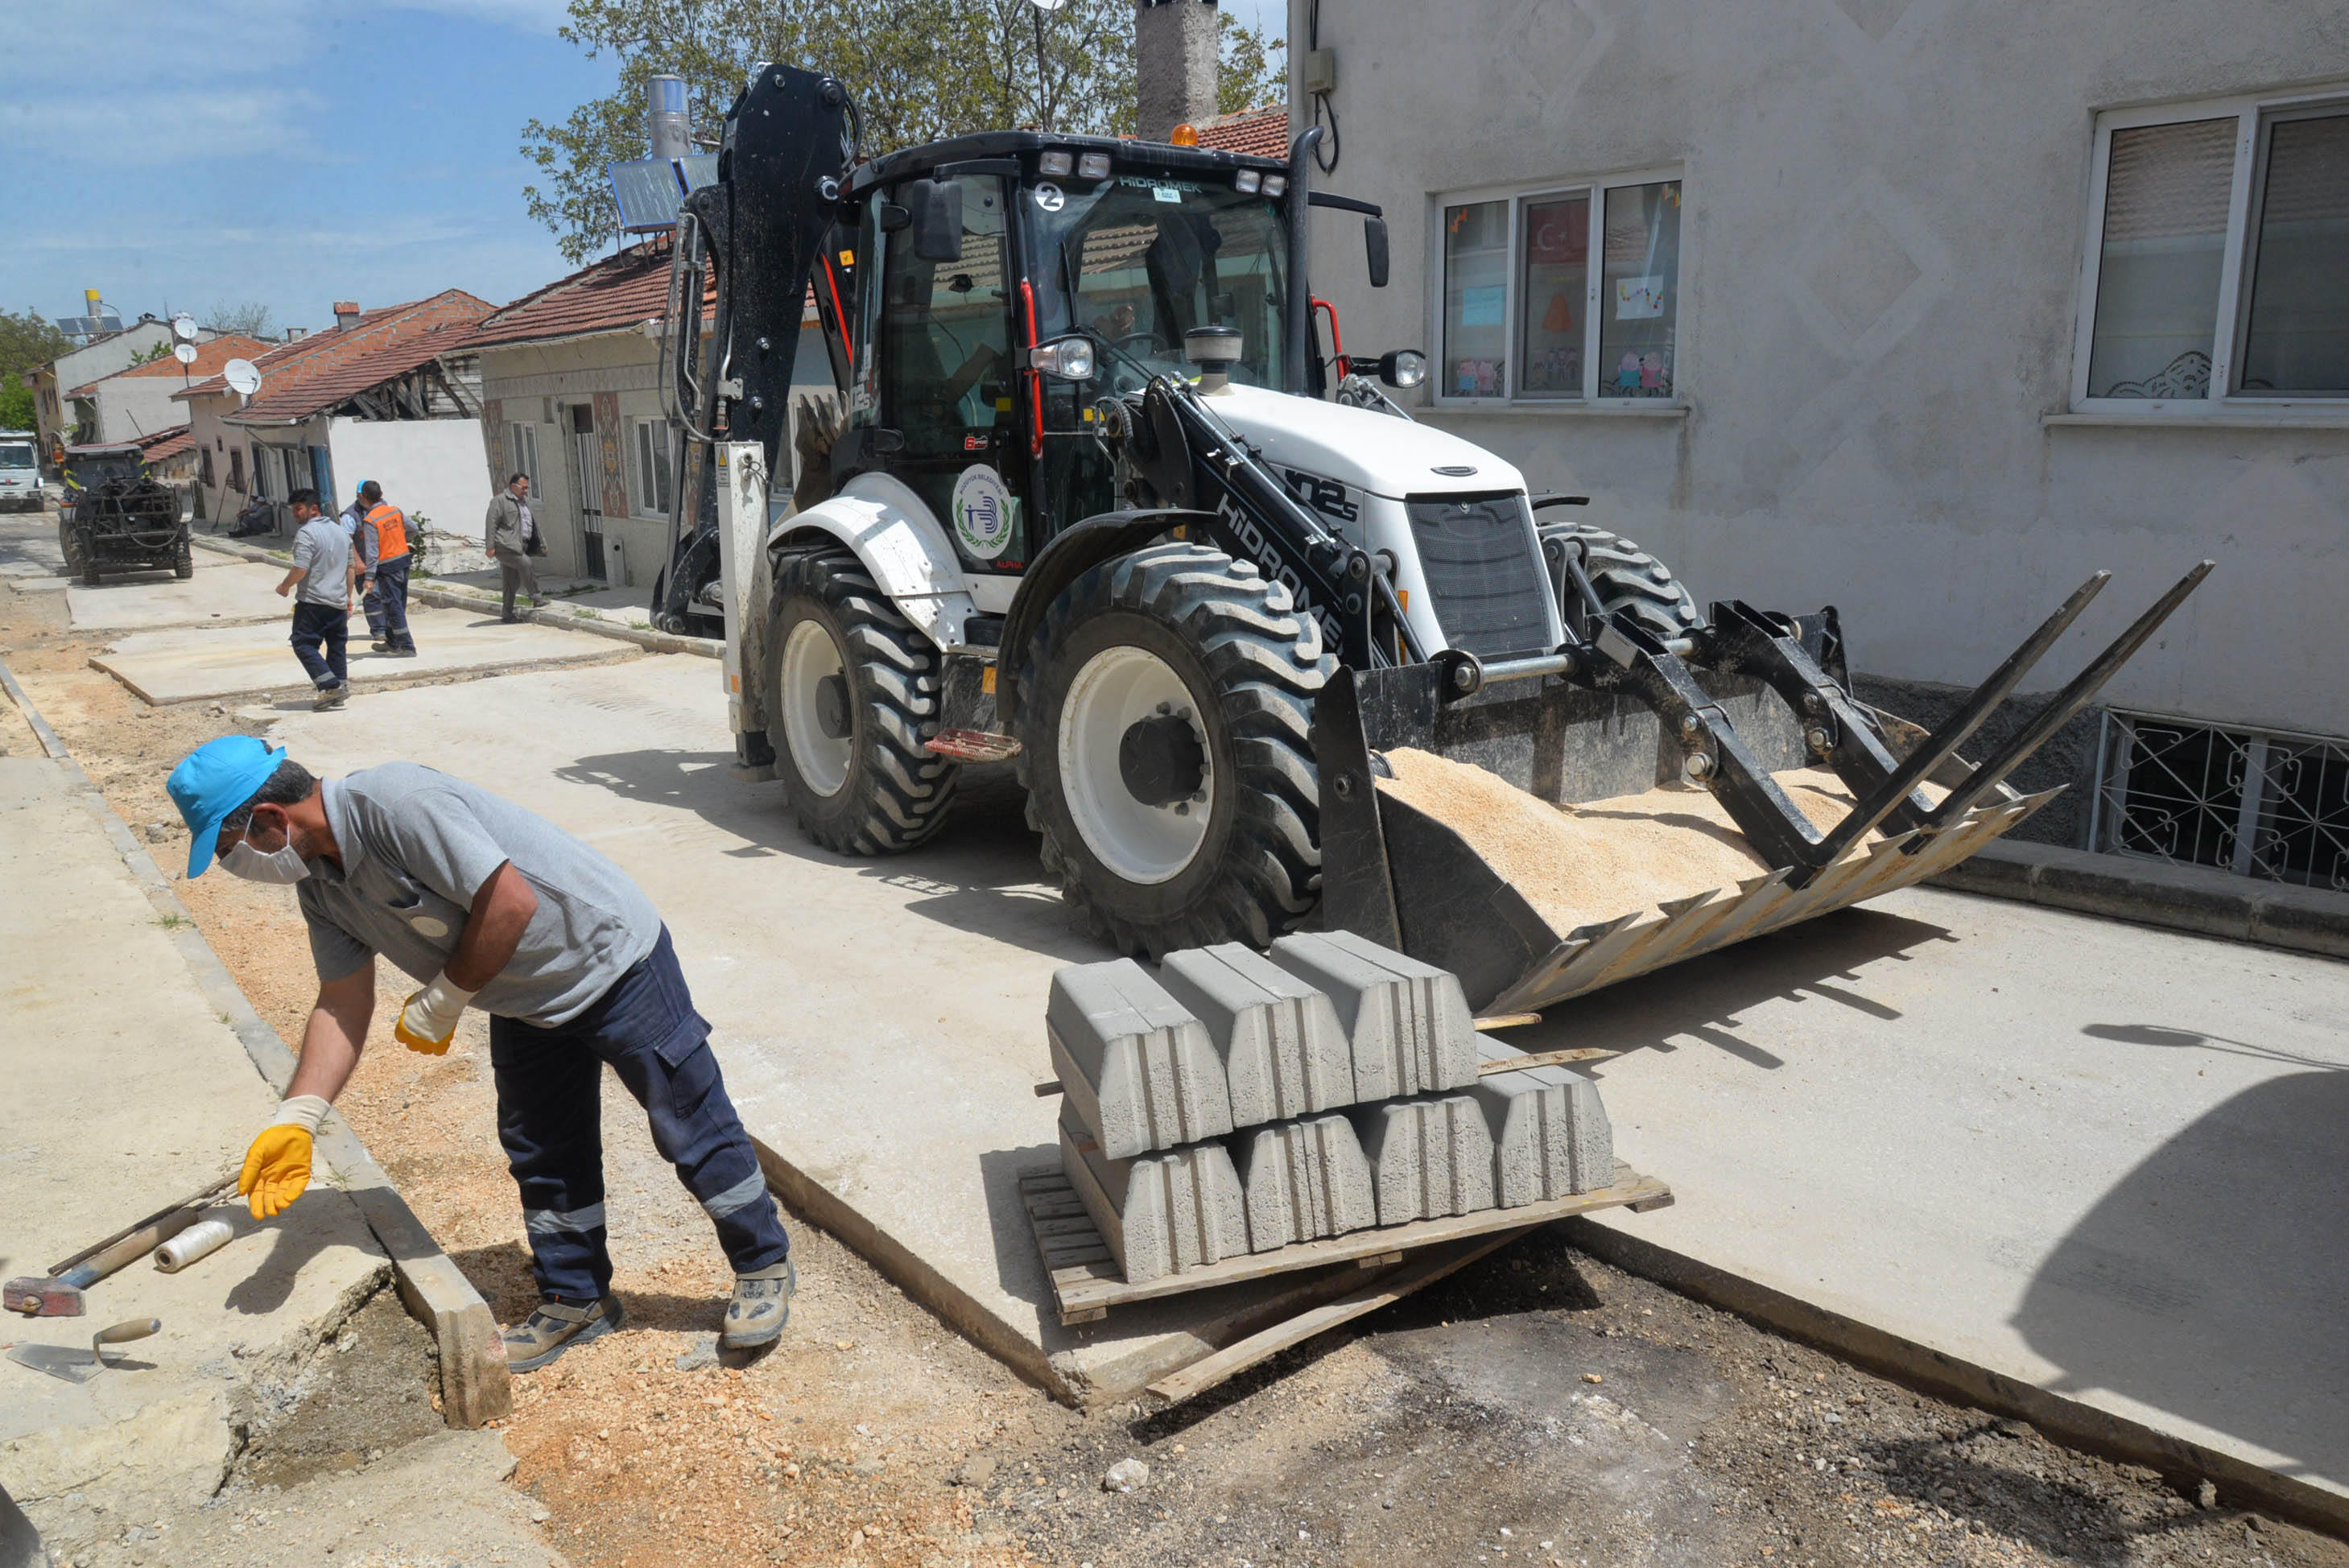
[522,0,1146,263]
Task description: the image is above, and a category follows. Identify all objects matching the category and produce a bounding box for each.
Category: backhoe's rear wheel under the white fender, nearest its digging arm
[766,549,954,854]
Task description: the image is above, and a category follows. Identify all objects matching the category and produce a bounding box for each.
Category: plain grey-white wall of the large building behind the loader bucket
[1290,0,2349,735]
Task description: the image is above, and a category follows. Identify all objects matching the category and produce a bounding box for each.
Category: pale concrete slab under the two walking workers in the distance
[92,605,627,704]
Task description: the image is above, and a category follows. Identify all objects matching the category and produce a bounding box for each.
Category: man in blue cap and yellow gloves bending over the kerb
[169,735,796,1371]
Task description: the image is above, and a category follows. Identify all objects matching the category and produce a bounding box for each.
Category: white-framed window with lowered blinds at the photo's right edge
[2072,92,2349,411]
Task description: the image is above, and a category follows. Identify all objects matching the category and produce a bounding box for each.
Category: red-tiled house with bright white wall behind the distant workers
[174,289,491,551]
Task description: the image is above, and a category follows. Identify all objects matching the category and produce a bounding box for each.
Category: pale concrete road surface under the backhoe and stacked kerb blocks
[252,658,2349,1488]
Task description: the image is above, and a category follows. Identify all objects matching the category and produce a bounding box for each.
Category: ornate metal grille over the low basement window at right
[2093,712,2349,892]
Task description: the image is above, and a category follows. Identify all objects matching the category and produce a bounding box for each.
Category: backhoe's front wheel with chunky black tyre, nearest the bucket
[1019,545,1336,958]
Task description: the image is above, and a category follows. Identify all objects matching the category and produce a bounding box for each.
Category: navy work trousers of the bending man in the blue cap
[489,927,791,1302]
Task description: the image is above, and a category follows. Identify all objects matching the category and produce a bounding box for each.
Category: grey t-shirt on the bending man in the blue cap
[299,763,660,1028]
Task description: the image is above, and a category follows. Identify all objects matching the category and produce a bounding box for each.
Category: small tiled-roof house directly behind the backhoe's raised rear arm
[468,237,832,594]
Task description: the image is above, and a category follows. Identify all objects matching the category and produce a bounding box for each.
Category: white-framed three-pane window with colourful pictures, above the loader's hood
[1435,174,1682,404]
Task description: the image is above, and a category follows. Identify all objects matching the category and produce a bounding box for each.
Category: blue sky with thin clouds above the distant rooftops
[0,0,1285,340]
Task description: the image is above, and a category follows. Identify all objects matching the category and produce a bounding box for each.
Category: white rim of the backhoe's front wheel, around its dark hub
[1059,646,1215,887]
